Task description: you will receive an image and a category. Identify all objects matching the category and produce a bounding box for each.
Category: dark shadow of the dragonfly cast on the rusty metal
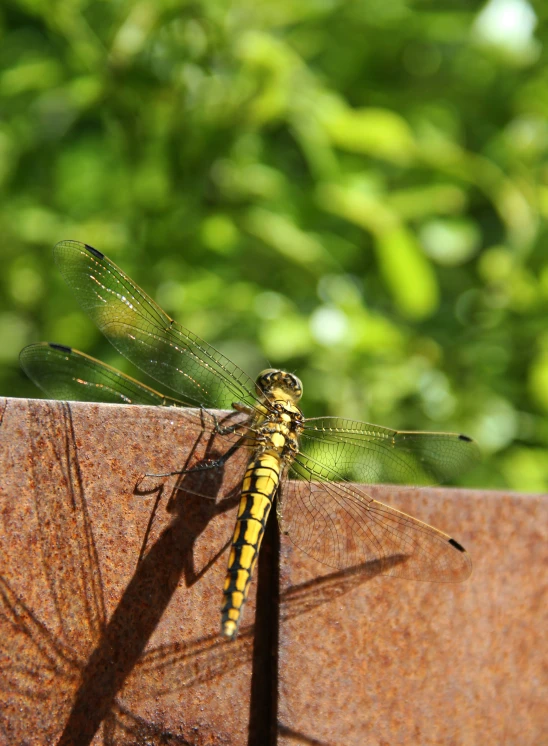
[0,402,398,746]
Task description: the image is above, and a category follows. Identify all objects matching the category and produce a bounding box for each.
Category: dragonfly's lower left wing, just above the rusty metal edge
[19,342,185,407]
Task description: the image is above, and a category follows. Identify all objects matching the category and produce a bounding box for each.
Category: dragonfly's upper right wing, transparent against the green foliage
[300,417,479,485]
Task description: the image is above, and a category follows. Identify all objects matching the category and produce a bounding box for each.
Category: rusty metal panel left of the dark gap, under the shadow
[0,399,254,746]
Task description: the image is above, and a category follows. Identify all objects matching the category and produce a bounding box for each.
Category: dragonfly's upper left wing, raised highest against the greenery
[54,241,256,409]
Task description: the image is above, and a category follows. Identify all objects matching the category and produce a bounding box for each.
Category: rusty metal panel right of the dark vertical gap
[278,480,548,746]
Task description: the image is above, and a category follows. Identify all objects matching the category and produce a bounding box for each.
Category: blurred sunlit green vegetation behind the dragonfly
[0,0,548,491]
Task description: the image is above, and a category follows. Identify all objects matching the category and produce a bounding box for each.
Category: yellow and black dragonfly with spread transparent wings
[20,241,478,639]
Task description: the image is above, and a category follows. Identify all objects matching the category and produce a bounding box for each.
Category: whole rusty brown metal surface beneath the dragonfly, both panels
[0,399,548,746]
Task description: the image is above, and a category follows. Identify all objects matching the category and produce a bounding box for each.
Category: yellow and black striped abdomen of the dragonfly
[221,453,281,637]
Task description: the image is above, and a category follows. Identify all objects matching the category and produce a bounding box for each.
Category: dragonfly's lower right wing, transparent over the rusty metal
[281,456,472,582]
